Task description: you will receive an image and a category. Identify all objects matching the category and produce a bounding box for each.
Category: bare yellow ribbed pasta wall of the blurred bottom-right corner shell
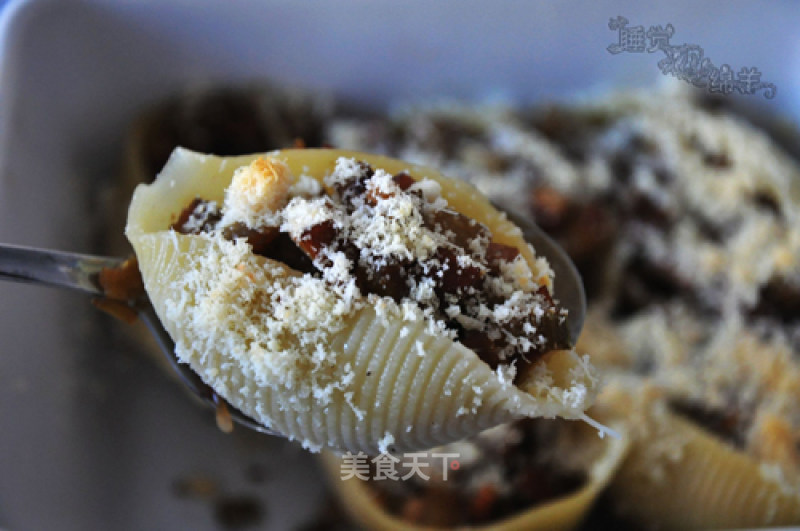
[610,413,800,529]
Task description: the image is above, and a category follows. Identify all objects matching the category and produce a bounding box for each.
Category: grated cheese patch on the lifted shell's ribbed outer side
[161,234,363,426]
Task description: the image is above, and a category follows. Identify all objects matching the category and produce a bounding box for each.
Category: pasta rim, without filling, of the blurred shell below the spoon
[322,417,629,531]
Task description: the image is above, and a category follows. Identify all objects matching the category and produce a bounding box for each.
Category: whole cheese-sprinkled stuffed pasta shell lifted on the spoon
[126,149,596,454]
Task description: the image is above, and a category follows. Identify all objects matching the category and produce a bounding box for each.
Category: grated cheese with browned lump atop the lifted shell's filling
[203,157,566,363]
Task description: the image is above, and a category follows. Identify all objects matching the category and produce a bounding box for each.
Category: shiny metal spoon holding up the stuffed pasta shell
[0,219,586,436]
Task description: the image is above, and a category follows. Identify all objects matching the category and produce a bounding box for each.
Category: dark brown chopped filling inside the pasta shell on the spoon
[171,162,569,374]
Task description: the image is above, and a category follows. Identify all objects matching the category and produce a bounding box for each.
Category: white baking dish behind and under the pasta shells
[0,0,800,530]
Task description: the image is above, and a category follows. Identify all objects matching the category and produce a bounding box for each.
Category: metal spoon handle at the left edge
[0,244,123,296]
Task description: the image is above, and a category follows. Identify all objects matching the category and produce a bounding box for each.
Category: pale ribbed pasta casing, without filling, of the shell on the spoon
[126,149,594,454]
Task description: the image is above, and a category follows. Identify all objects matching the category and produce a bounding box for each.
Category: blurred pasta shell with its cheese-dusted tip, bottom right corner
[599,386,800,529]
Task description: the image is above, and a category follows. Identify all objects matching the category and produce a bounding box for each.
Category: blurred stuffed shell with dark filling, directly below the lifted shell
[322,416,629,531]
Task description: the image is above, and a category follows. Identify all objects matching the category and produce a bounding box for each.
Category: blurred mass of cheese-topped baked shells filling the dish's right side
[329,90,800,529]
